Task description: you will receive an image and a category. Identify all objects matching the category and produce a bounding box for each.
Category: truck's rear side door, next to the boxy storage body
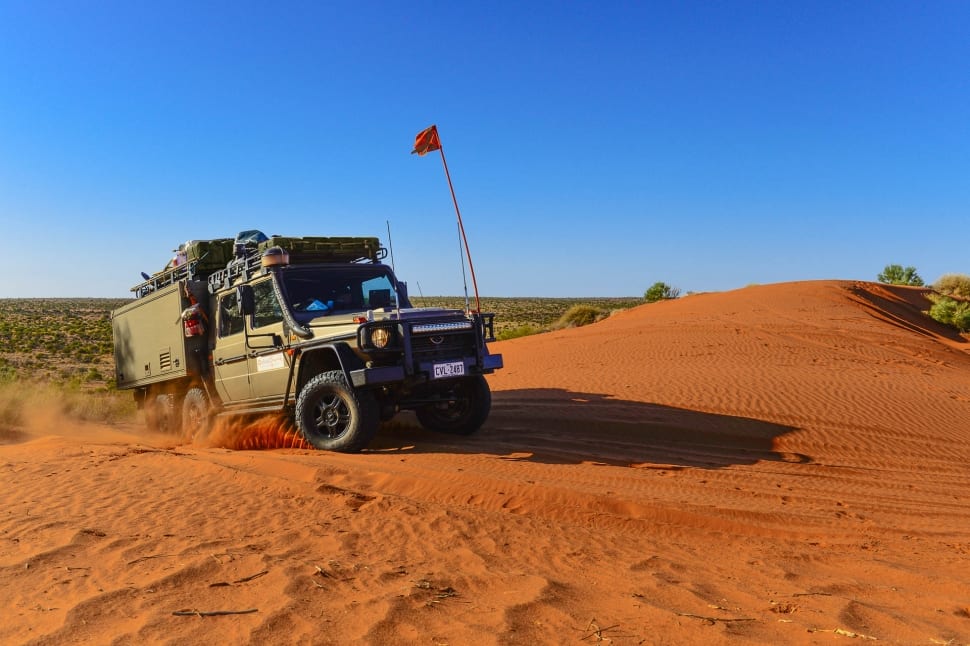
[212,290,252,402]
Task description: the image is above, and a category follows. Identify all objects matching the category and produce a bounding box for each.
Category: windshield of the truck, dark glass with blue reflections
[282,265,398,321]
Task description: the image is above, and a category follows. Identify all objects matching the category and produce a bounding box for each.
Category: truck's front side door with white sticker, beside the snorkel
[246,277,292,399]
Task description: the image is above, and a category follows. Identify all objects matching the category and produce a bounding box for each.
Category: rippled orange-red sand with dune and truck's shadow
[0,281,970,645]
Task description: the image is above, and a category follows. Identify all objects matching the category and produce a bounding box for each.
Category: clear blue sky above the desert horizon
[0,0,970,297]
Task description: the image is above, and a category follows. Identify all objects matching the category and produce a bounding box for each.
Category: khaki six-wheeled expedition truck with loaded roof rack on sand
[111,231,502,452]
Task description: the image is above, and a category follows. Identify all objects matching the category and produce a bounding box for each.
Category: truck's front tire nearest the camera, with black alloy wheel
[296,370,380,453]
